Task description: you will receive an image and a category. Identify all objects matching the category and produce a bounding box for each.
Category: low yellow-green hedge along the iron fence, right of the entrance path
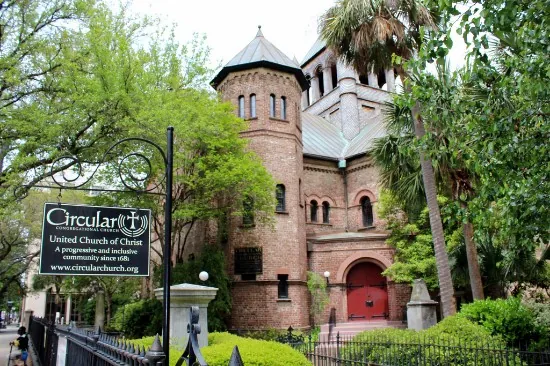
[342,315,512,365]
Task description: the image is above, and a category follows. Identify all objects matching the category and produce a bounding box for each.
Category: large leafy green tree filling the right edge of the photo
[408,0,550,296]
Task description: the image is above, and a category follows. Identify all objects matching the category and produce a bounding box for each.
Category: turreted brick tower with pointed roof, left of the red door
[212,27,309,329]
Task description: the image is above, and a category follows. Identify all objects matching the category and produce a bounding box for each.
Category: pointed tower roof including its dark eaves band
[210,26,308,90]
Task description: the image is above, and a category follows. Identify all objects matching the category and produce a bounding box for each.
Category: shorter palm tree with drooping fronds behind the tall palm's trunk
[370,63,484,300]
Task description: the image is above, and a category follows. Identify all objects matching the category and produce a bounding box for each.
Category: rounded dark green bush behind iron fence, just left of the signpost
[112,299,162,338]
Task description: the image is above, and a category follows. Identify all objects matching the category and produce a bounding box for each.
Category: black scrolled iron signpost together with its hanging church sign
[26,127,174,360]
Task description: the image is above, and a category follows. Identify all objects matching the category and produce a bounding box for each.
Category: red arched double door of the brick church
[346,262,389,321]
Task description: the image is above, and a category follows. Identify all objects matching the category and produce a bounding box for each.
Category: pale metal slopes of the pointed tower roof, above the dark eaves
[225,29,300,69]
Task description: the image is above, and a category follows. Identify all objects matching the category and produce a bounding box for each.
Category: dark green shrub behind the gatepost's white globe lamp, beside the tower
[162,244,231,331]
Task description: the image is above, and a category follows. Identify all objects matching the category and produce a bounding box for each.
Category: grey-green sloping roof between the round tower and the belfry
[302,112,386,160]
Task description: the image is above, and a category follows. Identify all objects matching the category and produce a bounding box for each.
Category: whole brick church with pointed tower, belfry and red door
[212,29,410,329]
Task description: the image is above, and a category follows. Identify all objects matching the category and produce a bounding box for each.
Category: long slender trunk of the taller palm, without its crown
[411,102,456,318]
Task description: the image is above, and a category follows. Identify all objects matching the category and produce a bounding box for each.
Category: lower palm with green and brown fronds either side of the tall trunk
[371,62,484,299]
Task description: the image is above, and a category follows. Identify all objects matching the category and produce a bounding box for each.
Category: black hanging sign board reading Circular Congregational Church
[40,203,151,276]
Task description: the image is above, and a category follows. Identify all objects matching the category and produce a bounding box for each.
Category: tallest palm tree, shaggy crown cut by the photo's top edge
[320,0,456,317]
